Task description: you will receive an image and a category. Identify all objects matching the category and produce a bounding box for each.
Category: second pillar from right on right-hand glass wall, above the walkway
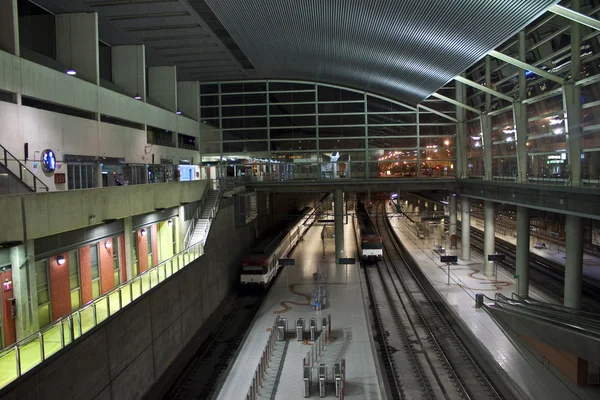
[513,30,528,183]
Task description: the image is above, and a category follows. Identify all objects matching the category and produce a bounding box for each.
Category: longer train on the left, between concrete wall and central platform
[240,207,315,289]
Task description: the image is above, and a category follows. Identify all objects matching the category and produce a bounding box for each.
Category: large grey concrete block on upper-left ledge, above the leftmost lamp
[55,13,100,85]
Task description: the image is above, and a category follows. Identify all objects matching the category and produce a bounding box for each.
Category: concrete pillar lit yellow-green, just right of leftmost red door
[10,240,40,341]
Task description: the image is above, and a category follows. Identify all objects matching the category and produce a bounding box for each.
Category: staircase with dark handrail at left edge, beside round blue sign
[0,145,48,195]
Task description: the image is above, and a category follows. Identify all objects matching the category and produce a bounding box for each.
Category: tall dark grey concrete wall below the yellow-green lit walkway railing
[0,205,254,400]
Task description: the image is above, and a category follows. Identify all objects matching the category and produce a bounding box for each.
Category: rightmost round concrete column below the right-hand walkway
[564,215,583,308]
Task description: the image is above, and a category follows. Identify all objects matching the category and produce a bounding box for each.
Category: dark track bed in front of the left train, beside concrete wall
[163,296,264,400]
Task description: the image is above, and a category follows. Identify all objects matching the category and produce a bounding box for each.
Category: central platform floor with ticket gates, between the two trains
[217,218,382,400]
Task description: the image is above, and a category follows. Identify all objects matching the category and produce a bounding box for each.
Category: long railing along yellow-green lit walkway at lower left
[0,242,204,388]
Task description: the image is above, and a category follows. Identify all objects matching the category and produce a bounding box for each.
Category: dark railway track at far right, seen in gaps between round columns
[464,227,600,313]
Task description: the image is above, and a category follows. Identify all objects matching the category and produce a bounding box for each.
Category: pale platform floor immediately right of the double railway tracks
[386,205,598,400]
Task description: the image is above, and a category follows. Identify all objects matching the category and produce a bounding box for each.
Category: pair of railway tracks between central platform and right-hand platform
[364,206,502,399]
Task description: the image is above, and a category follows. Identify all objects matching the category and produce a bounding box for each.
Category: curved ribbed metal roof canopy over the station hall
[36,0,557,105]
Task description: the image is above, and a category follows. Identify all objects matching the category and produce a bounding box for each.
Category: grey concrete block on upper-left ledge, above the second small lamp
[111,44,146,101]
